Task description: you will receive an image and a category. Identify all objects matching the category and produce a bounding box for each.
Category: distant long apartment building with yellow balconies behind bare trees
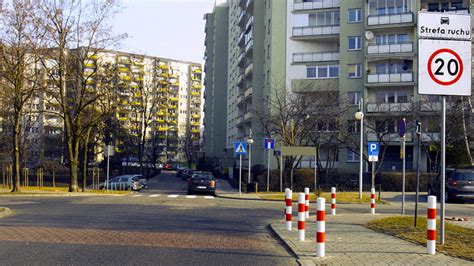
[19,50,202,166]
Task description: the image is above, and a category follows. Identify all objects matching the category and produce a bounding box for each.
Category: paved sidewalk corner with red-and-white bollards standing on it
[271,213,472,265]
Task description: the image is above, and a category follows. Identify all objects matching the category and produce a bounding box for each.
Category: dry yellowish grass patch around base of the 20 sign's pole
[367,216,474,261]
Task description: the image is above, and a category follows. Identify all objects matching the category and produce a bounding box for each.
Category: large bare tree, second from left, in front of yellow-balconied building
[38,0,122,192]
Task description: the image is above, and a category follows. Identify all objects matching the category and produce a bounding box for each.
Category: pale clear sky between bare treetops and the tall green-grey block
[114,0,215,64]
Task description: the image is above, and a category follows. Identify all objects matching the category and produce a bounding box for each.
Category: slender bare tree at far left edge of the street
[0,0,43,192]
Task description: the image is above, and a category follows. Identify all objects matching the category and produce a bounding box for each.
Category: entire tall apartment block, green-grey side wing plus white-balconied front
[205,0,472,175]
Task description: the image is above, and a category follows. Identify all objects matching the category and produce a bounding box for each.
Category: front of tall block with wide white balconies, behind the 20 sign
[286,0,470,171]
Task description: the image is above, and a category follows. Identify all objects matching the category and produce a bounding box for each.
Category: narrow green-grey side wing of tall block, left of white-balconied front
[204,0,286,166]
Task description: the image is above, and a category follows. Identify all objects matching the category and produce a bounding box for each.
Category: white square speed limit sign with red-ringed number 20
[418,39,471,96]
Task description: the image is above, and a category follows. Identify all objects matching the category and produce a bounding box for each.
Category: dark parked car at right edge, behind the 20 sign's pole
[428,169,474,202]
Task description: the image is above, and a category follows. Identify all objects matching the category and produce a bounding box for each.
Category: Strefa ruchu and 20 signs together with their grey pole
[418,12,471,245]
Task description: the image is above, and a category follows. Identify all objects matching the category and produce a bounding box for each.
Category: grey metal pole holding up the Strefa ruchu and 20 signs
[439,95,446,245]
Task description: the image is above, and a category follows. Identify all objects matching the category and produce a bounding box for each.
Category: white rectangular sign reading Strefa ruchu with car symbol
[418,12,471,41]
